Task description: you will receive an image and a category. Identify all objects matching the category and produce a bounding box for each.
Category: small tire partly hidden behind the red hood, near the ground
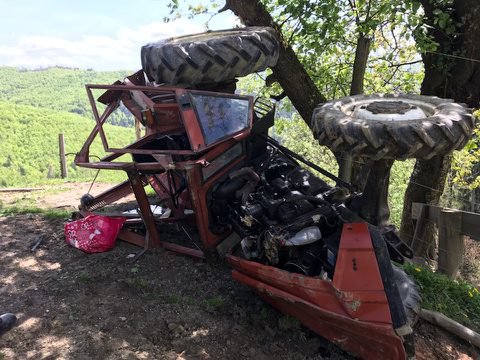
[392,264,422,328]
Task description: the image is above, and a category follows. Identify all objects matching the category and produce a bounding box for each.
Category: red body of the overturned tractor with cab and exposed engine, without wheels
[75,72,412,359]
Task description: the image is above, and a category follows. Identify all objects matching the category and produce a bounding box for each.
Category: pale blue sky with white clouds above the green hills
[0,0,238,70]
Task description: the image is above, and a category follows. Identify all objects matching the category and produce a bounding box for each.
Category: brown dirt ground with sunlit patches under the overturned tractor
[0,184,480,360]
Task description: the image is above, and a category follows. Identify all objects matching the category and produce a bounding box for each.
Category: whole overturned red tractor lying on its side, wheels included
[75,28,472,359]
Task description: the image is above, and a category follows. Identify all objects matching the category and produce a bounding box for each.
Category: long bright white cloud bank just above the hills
[0,19,203,70]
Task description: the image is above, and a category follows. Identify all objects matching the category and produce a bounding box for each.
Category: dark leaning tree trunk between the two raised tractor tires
[222,0,327,127]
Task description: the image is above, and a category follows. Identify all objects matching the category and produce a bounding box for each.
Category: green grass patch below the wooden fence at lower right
[404,264,480,331]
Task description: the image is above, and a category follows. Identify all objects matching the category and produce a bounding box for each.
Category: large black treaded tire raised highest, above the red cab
[141,27,279,87]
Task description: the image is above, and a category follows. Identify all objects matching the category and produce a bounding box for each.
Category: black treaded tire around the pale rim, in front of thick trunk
[312,94,475,160]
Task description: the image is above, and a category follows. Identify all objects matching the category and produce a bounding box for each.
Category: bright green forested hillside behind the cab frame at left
[0,67,135,187]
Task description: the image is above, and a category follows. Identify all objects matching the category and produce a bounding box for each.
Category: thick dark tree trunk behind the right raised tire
[400,0,480,250]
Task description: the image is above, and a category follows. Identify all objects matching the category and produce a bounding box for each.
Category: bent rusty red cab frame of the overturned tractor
[75,76,253,253]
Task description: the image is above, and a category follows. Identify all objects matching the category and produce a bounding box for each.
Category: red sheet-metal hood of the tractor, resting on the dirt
[227,223,406,359]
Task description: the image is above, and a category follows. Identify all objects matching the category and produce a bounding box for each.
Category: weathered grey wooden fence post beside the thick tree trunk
[438,209,465,279]
